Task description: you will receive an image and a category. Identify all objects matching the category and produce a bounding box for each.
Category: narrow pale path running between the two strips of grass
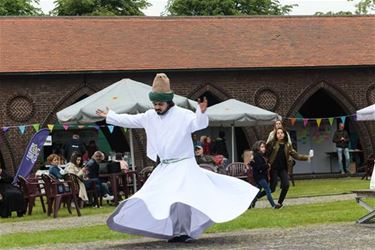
[0,194,355,235]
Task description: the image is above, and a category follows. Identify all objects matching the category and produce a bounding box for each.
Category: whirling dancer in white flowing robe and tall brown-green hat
[97,74,258,242]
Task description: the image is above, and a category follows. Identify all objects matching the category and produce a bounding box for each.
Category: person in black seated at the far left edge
[0,166,26,218]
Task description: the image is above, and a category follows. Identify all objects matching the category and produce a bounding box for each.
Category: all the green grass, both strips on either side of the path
[0,177,375,248]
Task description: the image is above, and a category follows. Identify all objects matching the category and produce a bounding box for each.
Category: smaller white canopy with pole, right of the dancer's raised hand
[207,99,281,162]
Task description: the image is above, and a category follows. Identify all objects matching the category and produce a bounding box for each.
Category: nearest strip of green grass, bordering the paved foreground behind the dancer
[0,200,375,248]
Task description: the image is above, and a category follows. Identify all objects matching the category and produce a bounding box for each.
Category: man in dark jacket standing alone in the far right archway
[332,123,350,174]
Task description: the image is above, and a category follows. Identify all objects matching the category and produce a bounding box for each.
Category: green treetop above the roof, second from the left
[51,0,150,16]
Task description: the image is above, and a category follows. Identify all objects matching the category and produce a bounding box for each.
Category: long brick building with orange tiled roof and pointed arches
[0,16,375,175]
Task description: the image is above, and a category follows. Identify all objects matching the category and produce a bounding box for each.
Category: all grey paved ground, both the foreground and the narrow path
[5,191,375,250]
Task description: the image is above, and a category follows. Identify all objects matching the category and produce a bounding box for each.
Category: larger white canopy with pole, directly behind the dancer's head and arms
[56,78,197,189]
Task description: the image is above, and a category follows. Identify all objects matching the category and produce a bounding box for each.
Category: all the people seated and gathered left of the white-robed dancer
[0,134,135,218]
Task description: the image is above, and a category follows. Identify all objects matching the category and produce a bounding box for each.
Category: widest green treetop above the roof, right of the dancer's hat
[163,0,297,16]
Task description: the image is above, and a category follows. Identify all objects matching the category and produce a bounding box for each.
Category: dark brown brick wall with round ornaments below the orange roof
[0,67,375,173]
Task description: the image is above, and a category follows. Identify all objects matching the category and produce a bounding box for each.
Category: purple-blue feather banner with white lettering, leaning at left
[13,128,49,184]
